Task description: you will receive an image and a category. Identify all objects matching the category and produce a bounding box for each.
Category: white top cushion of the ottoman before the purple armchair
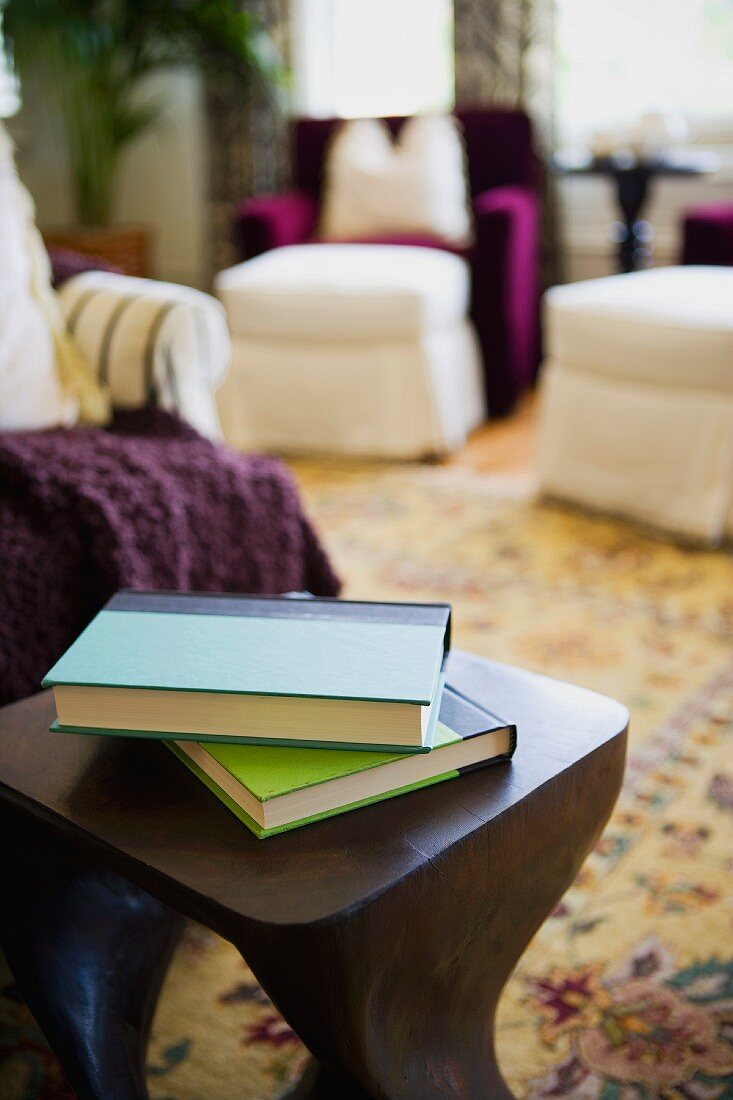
[216,244,470,343]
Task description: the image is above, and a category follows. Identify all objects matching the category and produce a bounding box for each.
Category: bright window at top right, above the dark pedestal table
[557,0,733,142]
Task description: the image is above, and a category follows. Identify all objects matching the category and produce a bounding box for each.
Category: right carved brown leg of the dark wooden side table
[235,746,623,1100]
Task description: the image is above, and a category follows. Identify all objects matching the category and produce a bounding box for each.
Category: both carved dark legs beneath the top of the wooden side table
[0,756,615,1100]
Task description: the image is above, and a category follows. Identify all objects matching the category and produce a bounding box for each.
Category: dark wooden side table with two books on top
[0,652,627,1100]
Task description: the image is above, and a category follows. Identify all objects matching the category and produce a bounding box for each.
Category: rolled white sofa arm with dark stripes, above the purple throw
[58,271,230,439]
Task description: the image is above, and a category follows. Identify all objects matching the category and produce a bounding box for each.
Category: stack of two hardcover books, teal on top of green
[44,592,516,837]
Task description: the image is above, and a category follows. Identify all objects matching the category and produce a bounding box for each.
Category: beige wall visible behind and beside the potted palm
[12,69,208,286]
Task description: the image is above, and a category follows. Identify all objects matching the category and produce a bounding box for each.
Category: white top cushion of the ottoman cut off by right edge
[546,266,733,393]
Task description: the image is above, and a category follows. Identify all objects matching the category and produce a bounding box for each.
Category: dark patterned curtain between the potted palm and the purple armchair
[206,0,291,274]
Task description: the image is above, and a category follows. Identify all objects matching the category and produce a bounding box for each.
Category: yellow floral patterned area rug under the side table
[0,463,733,1100]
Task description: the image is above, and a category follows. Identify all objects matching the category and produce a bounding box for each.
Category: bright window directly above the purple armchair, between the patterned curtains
[294,0,453,118]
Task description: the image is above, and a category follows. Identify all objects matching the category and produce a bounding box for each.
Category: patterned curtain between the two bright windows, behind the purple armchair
[453,0,561,284]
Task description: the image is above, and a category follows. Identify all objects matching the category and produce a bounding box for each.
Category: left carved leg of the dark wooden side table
[0,827,183,1100]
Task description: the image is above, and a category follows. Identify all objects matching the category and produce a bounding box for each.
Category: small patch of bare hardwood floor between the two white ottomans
[446,394,537,475]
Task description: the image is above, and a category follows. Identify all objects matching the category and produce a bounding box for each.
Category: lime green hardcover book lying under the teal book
[166,686,516,839]
